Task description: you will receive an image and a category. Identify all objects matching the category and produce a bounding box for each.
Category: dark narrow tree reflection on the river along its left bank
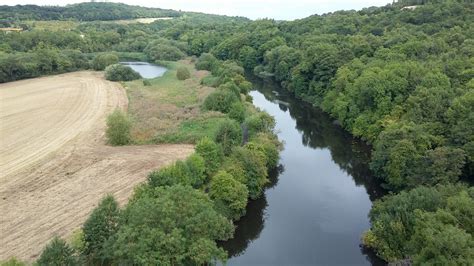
[218,165,284,257]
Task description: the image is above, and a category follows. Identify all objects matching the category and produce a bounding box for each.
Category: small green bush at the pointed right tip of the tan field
[196,138,222,177]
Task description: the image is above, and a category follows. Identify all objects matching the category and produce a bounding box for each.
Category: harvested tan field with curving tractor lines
[0,72,193,261]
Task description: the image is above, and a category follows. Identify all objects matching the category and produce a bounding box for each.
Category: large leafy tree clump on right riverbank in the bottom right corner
[364,185,474,265]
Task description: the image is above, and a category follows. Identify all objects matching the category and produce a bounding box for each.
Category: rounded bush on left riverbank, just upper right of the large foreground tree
[209,171,249,220]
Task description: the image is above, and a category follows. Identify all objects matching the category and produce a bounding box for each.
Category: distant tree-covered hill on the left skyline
[0,3,182,21]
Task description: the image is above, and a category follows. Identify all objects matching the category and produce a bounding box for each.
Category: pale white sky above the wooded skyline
[4,0,392,20]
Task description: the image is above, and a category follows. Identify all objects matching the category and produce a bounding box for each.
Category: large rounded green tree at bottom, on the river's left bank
[109,186,233,265]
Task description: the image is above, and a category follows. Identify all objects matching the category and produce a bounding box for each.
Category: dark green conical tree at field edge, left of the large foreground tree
[82,195,120,264]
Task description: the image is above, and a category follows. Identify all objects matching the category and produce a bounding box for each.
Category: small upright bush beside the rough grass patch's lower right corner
[214,119,242,155]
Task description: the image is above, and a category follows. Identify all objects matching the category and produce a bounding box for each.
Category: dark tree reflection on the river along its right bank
[254,77,384,201]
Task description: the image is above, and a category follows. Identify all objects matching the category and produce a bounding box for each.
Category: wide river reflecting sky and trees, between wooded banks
[220,80,384,265]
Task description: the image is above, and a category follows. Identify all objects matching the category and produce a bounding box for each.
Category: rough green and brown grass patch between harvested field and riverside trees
[124,60,224,144]
